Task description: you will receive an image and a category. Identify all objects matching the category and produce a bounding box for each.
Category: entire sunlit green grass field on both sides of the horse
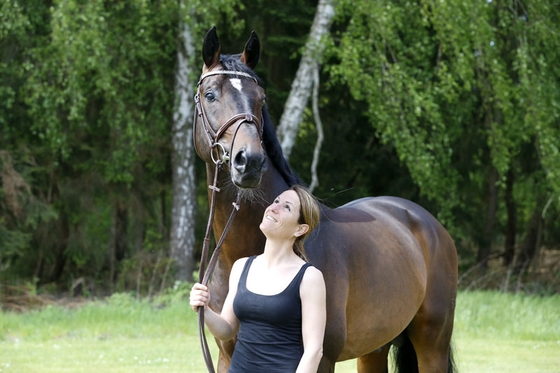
[0,292,560,373]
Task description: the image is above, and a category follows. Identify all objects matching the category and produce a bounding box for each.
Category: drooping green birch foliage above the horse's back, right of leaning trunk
[327,1,560,260]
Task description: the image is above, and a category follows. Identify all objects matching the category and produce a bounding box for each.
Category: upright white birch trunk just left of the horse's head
[167,0,243,281]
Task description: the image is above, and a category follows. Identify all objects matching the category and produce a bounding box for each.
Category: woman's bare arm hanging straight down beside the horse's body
[296,267,327,373]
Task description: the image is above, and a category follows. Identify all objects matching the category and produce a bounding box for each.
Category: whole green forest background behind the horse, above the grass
[0,0,560,297]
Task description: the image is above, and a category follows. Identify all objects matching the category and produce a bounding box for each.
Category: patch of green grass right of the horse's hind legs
[454,291,560,372]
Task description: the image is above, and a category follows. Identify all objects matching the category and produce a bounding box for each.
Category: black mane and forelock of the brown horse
[220,54,304,186]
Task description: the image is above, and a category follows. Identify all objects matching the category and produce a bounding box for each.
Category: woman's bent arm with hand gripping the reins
[190,258,246,341]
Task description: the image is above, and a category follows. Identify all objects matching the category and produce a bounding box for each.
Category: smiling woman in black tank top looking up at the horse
[190,185,326,373]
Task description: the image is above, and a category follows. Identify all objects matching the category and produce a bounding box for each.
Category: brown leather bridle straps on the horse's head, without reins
[193,70,263,164]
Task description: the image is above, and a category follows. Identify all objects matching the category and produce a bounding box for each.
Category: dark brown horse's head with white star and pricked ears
[194,27,267,189]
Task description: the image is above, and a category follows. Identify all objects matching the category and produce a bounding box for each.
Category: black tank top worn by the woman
[228,256,310,373]
